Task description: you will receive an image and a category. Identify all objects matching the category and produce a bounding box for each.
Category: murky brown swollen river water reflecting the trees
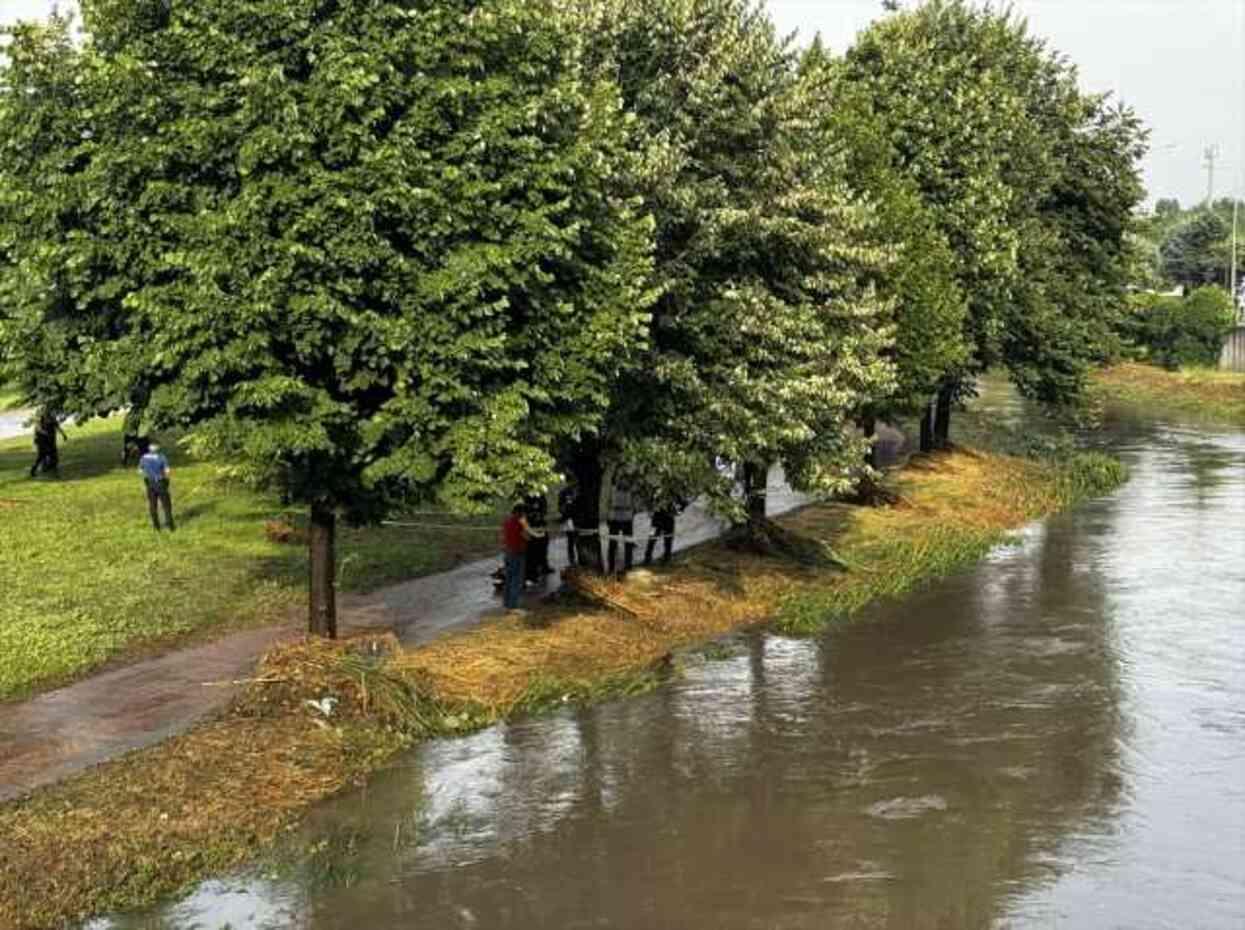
[96,413,1245,930]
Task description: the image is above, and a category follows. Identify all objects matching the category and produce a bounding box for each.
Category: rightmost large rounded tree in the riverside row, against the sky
[844,0,1143,442]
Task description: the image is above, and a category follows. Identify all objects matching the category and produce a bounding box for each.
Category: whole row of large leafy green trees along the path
[0,0,1145,634]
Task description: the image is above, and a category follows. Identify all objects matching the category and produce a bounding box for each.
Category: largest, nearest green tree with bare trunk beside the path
[60,0,651,635]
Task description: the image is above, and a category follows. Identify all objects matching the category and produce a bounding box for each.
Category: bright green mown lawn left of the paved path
[0,421,497,701]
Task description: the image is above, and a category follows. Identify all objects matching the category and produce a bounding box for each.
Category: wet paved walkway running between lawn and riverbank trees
[0,428,894,801]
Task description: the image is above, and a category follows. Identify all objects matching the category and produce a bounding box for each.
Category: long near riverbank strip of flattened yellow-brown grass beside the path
[0,452,1124,930]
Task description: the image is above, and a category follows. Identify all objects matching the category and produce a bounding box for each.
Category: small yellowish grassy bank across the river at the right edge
[1094,364,1245,426]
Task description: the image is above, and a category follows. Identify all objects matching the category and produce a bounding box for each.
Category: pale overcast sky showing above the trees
[0,0,1245,203]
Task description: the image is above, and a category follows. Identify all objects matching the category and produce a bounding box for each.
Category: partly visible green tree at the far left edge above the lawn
[0,16,120,440]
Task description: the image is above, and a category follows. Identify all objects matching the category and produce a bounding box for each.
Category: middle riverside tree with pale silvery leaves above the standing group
[565,0,891,550]
